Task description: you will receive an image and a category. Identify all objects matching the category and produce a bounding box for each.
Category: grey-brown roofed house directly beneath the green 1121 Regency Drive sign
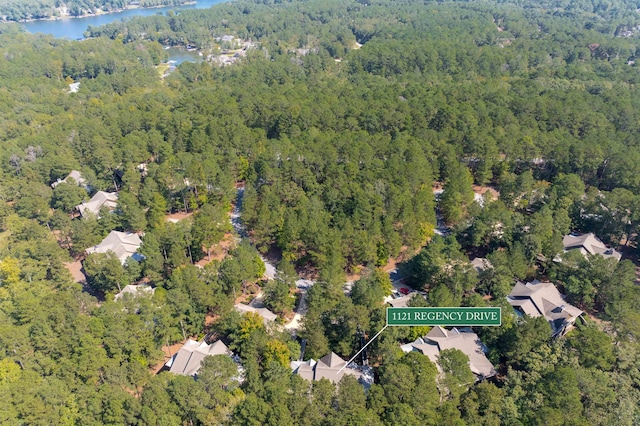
[401,326,496,380]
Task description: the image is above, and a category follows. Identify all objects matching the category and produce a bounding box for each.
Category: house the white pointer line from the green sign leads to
[291,352,373,387]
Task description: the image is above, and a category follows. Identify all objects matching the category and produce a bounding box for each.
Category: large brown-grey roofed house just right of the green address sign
[507,281,582,337]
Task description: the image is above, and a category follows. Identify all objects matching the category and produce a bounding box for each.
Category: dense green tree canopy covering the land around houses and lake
[0,0,640,425]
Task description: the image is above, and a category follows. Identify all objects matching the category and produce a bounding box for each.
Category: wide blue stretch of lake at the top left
[21,0,227,40]
